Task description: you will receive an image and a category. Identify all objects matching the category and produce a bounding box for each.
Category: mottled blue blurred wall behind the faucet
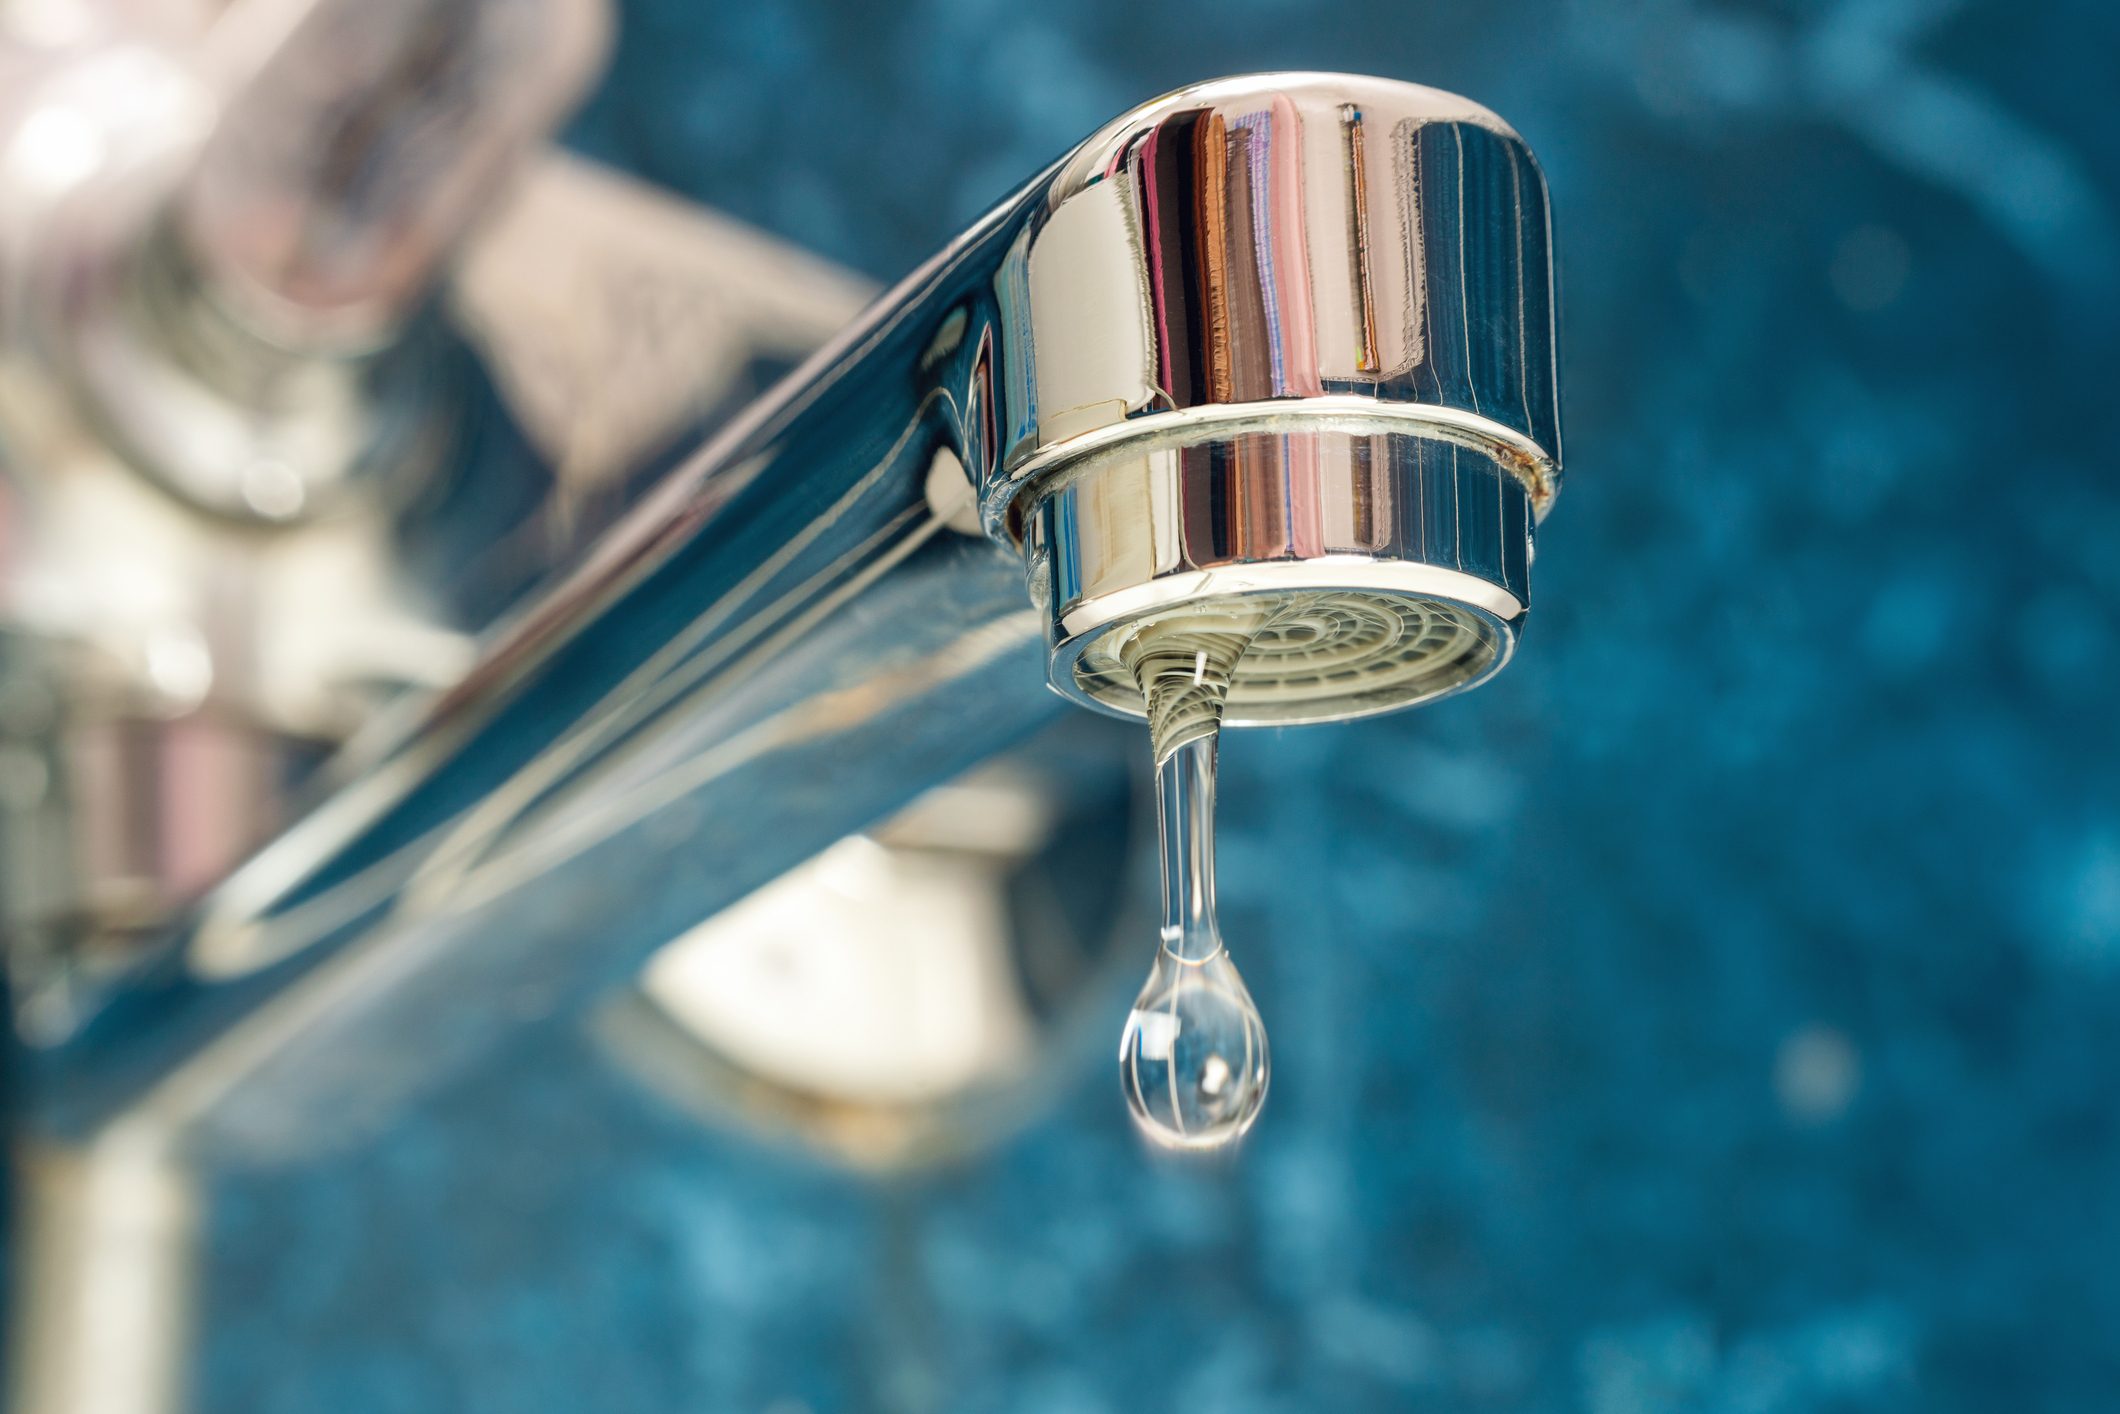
[197,0,2120,1414]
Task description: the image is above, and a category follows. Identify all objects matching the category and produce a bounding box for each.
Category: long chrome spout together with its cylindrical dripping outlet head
[0,63,1560,1407]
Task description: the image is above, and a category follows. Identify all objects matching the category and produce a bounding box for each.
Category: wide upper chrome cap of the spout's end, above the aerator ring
[979,74,1560,517]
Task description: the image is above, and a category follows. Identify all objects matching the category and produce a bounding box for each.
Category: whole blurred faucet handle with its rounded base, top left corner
[0,0,606,526]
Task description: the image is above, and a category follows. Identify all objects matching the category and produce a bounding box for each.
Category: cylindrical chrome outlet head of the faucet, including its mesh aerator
[979,74,1560,725]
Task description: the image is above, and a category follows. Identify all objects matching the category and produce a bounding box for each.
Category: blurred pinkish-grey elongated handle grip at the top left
[172,0,611,352]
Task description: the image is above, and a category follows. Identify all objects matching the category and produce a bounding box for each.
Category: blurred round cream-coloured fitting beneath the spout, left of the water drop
[591,750,1147,1172]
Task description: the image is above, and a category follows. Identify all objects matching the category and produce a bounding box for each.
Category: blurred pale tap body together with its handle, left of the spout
[0,0,614,1037]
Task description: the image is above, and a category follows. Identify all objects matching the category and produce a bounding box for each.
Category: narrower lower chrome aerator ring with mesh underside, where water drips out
[1024,420,1531,725]
